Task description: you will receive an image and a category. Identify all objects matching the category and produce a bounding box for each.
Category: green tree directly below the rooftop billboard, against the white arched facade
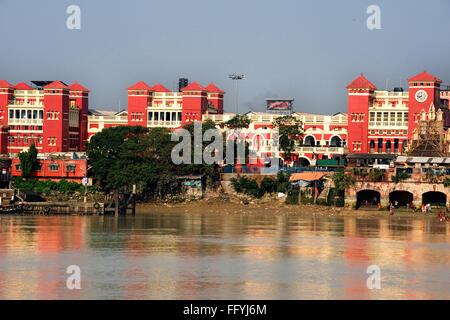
[274,115,303,160]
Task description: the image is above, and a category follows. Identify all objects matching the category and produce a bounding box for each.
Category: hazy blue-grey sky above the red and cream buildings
[0,0,450,114]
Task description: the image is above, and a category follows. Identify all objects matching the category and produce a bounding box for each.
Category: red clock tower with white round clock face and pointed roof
[408,71,442,139]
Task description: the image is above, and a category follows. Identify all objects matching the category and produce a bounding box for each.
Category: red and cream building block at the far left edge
[0,80,89,154]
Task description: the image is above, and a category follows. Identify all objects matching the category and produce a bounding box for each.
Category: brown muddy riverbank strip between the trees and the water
[136,198,437,219]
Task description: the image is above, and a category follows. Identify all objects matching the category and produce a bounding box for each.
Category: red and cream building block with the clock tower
[347,71,450,154]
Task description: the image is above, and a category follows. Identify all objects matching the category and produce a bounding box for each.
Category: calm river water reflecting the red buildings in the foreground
[0,213,450,299]
